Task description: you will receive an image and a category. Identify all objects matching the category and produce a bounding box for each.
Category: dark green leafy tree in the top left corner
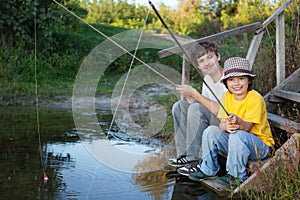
[0,0,85,49]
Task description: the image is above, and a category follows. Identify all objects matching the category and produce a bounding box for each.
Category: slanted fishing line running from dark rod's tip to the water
[108,8,150,136]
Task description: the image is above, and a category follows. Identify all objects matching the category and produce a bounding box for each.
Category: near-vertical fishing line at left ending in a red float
[33,0,48,182]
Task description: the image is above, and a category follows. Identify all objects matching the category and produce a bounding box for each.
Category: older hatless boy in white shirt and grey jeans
[169,42,227,175]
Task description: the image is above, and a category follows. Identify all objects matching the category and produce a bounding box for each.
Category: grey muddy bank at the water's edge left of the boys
[46,87,178,138]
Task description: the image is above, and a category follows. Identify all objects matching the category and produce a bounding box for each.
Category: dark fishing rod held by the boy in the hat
[149,0,229,116]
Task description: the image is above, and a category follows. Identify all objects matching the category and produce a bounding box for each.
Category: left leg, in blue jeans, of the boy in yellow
[200,126,229,176]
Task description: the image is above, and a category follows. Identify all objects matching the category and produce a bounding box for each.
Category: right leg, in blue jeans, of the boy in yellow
[226,130,269,182]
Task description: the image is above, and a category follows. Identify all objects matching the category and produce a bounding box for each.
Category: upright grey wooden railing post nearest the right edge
[276,11,285,85]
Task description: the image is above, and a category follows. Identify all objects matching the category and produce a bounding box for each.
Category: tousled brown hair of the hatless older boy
[191,42,220,63]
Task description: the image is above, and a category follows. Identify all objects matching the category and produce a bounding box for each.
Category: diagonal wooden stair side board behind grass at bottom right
[231,133,300,197]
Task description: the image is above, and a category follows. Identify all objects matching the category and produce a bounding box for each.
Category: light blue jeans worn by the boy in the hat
[200,126,269,182]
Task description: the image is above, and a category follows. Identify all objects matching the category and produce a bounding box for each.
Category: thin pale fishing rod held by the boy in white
[52,0,177,86]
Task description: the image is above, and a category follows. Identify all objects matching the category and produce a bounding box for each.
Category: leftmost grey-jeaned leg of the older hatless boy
[172,100,190,157]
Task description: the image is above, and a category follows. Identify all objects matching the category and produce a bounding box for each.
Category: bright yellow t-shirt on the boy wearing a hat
[218,90,275,146]
